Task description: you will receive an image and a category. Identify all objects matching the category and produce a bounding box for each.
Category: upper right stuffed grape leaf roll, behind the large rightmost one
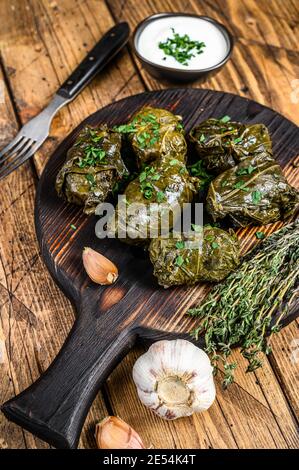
[189,119,272,175]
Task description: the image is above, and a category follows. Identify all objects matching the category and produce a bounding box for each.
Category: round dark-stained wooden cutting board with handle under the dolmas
[2,89,299,448]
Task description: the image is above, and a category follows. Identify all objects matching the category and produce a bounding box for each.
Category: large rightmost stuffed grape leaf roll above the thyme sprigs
[207,155,298,227]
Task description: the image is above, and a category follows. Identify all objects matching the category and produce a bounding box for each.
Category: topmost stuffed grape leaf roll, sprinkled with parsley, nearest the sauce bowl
[117,106,187,168]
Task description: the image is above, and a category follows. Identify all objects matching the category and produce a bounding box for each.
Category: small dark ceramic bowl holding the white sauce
[133,13,234,82]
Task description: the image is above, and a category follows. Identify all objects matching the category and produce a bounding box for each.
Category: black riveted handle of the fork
[57,22,130,101]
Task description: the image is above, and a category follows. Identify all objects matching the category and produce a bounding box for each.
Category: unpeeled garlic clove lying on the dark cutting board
[82,247,118,285]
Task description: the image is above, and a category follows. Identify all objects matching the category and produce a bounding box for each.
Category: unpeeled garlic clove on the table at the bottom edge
[95,416,145,449]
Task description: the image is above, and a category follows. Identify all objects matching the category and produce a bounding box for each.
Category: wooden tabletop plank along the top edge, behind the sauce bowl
[107,0,299,51]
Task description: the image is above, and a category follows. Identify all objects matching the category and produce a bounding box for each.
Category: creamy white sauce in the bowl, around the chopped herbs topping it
[136,16,229,70]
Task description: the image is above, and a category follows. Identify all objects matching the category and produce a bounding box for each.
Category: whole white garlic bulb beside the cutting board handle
[133,339,216,419]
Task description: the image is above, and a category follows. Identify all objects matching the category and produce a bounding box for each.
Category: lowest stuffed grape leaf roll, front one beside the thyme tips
[149,226,240,287]
